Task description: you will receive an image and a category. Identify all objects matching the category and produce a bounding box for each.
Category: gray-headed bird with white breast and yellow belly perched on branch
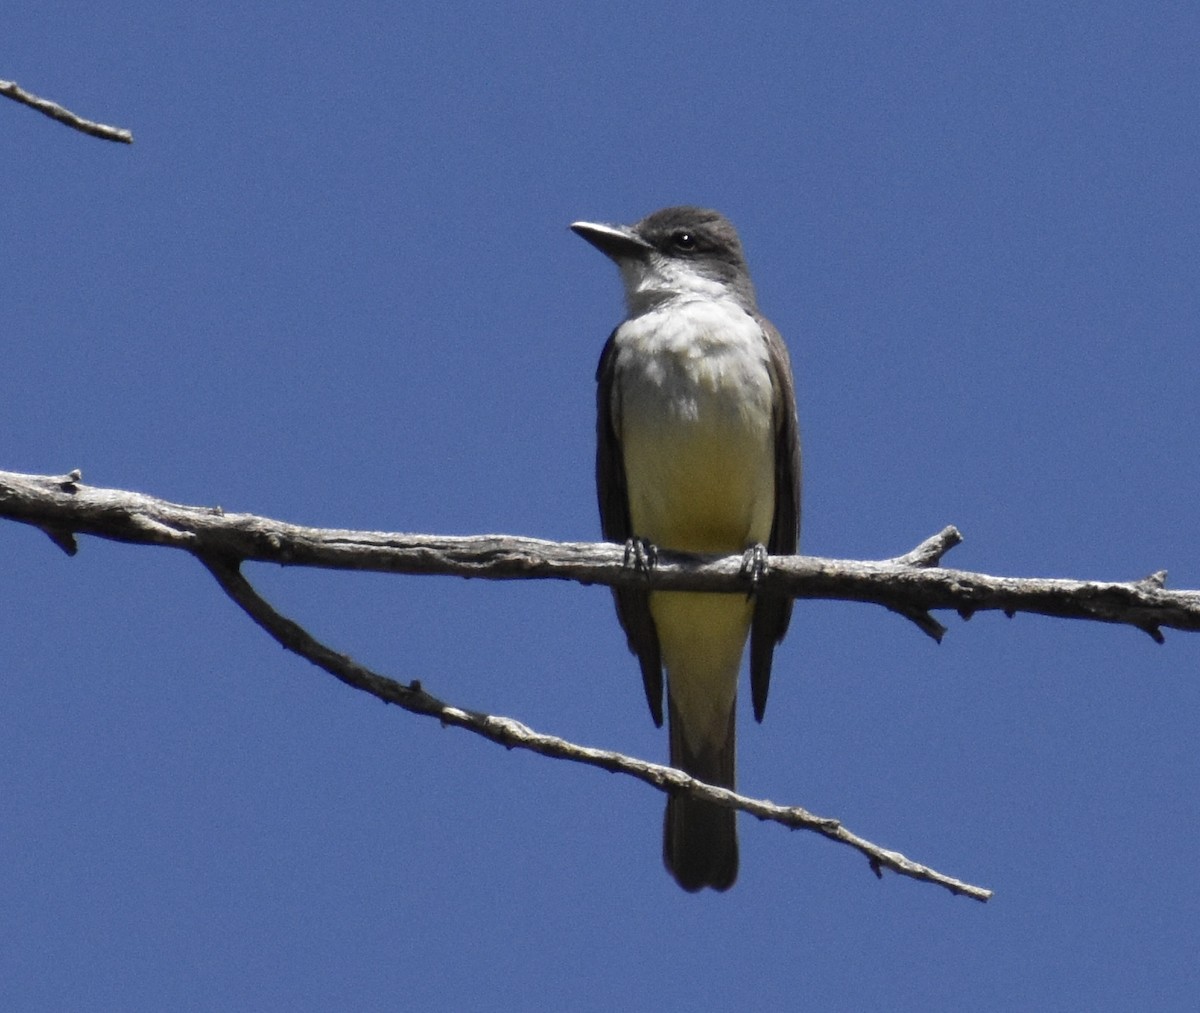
[571,205,800,893]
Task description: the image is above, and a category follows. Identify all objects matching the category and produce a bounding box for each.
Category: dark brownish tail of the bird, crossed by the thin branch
[662,694,738,893]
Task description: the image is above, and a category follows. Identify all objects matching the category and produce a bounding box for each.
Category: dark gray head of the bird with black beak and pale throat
[571,206,756,313]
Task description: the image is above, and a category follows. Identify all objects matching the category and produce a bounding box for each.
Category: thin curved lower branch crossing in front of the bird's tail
[200,556,992,901]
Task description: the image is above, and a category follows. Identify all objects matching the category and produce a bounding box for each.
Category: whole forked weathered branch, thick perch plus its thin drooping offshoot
[7,472,1200,900]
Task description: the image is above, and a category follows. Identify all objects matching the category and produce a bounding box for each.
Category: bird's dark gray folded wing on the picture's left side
[596,331,667,727]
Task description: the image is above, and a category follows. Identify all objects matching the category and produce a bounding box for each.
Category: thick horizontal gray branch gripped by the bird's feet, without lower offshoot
[0,472,1200,640]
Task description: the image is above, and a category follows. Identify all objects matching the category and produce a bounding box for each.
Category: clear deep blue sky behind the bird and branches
[0,2,1200,1011]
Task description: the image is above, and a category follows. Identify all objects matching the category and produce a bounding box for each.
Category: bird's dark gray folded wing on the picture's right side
[750,313,800,721]
